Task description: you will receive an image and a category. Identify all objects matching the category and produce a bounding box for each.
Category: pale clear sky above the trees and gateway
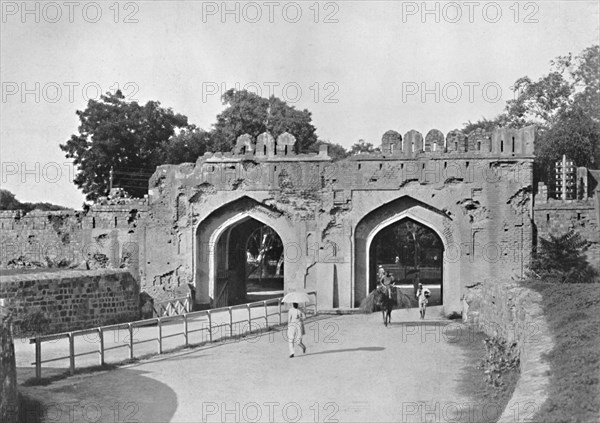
[0,0,600,209]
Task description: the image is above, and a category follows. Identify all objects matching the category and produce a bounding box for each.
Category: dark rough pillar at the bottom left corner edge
[0,314,18,423]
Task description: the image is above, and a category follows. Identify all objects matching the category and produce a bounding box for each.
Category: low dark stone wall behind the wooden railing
[0,269,140,336]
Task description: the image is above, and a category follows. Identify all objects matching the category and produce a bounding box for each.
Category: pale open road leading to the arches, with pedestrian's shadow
[18,310,478,422]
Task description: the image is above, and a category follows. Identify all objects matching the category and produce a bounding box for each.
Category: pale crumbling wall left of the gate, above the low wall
[0,200,147,277]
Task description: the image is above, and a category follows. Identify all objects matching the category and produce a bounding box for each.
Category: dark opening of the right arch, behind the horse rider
[369,218,444,306]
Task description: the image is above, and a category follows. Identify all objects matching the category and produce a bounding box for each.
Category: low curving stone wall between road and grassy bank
[463,280,554,423]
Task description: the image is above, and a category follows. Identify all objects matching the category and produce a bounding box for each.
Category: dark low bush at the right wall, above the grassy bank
[530,231,597,283]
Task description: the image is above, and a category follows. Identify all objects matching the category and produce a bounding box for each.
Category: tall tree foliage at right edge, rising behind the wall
[463,45,600,182]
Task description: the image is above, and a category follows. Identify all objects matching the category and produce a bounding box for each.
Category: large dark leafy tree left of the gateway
[60,91,187,200]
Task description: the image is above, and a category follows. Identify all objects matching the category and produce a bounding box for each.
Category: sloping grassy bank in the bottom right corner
[529,282,600,422]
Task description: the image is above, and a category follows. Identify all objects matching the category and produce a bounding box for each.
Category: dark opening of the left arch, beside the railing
[214,218,285,307]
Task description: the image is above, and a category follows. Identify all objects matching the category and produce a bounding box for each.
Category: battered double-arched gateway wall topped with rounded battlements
[142,128,534,312]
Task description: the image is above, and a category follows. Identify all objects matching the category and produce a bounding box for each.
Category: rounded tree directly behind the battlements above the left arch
[211,89,317,153]
